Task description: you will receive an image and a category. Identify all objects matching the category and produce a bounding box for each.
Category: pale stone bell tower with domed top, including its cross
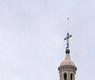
[58,33,77,80]
